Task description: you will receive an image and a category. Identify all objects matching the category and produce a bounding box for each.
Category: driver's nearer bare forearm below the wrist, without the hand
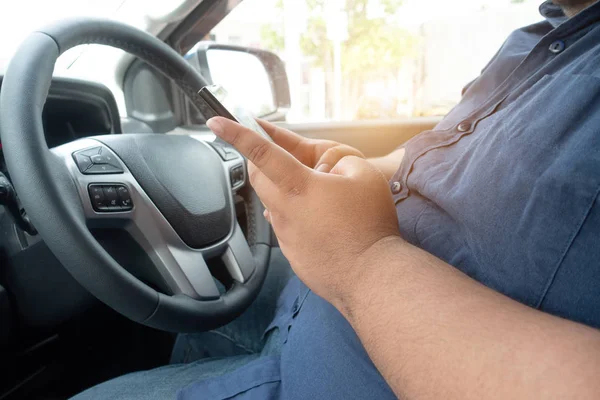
[333,238,600,399]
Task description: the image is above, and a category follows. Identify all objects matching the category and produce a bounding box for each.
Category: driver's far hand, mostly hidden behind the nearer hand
[258,120,365,172]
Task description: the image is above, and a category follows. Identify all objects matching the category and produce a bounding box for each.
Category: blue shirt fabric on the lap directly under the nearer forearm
[280,284,396,400]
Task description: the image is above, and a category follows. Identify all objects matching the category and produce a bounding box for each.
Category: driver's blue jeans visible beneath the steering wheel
[74,249,294,400]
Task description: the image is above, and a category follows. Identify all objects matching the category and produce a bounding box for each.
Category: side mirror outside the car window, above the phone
[185,42,291,123]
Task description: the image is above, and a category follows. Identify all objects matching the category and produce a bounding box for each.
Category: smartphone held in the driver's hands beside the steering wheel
[198,85,273,142]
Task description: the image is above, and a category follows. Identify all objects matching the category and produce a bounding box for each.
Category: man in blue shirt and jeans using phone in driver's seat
[75,0,600,399]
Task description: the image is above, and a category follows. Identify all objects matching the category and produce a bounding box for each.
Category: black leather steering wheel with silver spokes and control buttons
[0,19,271,332]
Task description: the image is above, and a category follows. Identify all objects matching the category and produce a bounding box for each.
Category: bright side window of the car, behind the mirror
[210,0,541,122]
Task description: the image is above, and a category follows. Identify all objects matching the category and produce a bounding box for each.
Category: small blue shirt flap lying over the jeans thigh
[177,357,281,400]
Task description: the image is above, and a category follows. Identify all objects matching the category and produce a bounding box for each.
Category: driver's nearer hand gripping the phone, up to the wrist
[207,117,399,305]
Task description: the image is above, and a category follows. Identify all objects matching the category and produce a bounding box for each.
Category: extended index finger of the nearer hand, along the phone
[206,117,309,193]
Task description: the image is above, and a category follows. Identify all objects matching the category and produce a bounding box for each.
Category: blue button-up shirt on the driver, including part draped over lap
[179,2,600,399]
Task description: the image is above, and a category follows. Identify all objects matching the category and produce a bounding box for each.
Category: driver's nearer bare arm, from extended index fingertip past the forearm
[208,118,600,399]
